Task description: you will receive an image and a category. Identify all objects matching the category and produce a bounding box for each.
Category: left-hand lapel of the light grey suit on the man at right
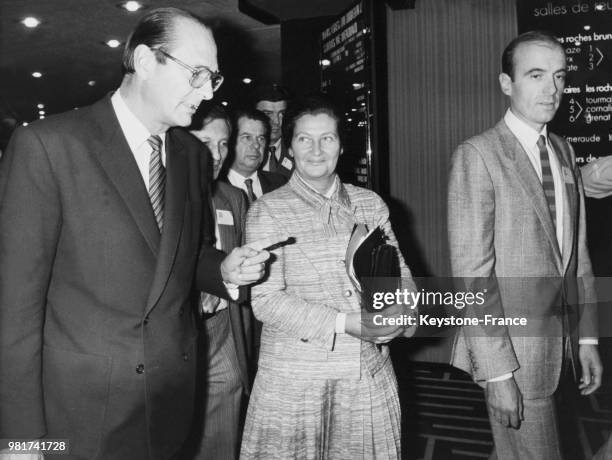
[497,120,562,272]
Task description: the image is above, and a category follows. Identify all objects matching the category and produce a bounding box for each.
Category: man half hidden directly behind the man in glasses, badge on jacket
[190,107,254,460]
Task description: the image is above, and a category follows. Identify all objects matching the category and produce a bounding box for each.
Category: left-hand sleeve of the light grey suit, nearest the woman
[448,143,519,381]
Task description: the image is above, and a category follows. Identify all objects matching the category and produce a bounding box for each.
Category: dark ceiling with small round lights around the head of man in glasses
[0,0,281,122]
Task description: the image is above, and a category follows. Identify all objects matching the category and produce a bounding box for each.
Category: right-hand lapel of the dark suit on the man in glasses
[147,130,188,312]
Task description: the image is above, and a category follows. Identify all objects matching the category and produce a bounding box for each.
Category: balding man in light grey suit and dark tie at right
[448,32,602,460]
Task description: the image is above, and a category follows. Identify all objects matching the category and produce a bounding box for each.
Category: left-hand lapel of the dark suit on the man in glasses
[92,97,160,255]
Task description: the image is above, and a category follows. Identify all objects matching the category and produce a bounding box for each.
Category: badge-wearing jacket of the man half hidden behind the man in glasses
[213,181,253,393]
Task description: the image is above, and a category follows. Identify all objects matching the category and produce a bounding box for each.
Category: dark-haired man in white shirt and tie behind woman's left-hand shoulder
[227,109,287,202]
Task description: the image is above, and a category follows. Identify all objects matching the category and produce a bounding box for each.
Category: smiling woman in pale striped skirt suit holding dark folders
[241,96,414,460]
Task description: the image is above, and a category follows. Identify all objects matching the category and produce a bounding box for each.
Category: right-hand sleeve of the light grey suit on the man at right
[570,146,599,338]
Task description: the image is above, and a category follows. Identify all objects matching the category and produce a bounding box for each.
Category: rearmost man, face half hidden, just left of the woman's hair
[253,83,295,179]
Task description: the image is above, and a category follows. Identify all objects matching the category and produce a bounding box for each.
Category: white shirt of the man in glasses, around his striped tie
[111,90,166,190]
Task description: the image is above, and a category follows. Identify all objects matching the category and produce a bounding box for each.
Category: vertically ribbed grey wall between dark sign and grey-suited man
[387,0,517,275]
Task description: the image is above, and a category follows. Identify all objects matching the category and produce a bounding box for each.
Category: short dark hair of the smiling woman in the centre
[283,93,344,148]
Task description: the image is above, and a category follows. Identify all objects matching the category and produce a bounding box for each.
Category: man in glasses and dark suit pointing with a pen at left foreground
[0,8,268,460]
